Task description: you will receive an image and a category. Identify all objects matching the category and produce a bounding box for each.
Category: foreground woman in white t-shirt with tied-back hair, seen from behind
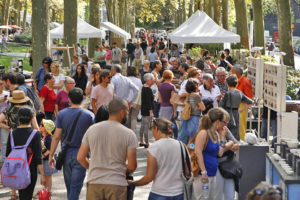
[133,118,184,200]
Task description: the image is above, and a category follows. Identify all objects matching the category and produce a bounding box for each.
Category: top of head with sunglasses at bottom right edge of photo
[247,182,282,200]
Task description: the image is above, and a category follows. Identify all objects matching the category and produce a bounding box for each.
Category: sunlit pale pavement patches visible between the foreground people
[0,123,154,200]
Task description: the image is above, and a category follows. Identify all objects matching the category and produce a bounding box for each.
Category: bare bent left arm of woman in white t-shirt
[134,152,157,186]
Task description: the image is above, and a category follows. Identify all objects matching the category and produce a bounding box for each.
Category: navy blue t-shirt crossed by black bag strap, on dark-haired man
[56,108,95,149]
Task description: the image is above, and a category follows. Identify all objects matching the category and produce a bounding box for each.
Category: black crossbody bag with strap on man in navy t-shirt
[55,109,83,170]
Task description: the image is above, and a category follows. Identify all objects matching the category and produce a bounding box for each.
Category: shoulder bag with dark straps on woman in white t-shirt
[179,141,196,200]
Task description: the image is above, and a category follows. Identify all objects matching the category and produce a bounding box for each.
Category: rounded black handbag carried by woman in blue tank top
[219,150,243,179]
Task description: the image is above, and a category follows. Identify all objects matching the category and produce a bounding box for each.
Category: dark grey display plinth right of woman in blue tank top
[237,144,269,200]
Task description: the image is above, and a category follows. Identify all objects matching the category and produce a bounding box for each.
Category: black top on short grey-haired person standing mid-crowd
[141,86,154,116]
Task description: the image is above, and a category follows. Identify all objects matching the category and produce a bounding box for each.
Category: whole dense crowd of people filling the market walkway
[0,32,282,200]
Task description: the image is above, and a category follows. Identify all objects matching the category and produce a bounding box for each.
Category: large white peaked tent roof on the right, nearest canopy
[169,10,240,43]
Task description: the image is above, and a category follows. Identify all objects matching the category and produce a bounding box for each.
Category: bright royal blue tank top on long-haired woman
[203,136,220,176]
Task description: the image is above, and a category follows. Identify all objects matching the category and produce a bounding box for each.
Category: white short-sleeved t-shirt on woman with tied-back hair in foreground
[148,138,183,197]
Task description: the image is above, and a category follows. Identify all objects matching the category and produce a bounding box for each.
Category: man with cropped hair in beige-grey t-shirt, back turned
[77,98,138,200]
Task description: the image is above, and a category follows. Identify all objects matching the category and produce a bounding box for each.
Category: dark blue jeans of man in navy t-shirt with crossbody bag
[63,149,86,200]
